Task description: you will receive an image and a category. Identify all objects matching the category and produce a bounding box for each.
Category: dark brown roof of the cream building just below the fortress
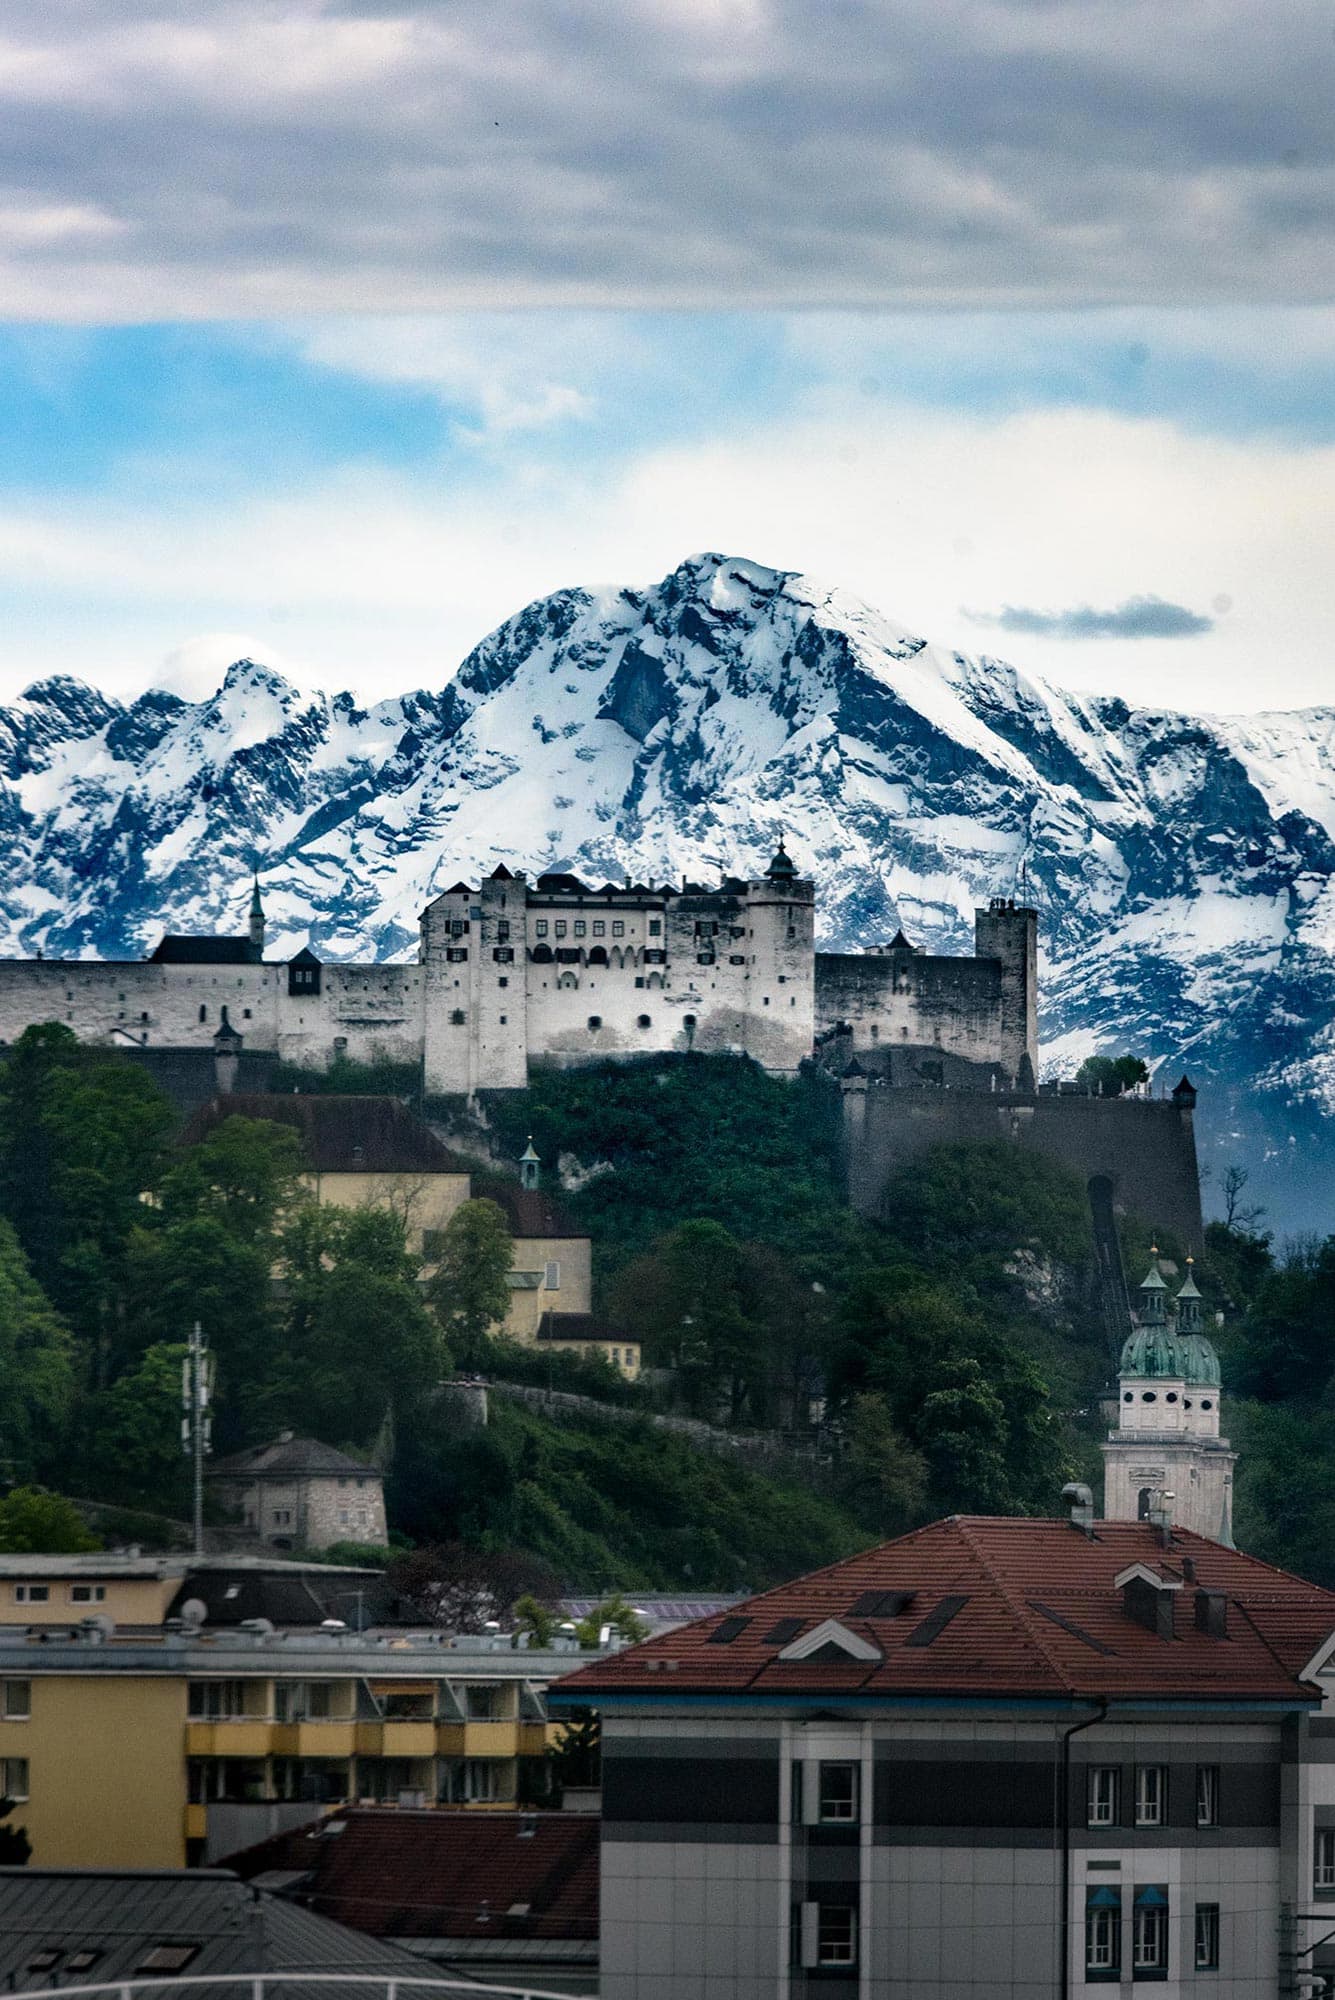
[180,1090,468,1174]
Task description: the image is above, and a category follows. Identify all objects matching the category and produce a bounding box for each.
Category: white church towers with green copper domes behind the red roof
[1103,1252,1237,1548]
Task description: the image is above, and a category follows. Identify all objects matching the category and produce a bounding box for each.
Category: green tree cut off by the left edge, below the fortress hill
[0,1218,76,1476]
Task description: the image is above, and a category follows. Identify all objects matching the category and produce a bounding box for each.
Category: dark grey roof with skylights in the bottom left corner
[0,1868,424,2000]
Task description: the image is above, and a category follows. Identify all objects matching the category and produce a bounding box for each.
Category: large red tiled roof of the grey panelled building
[560,1516,1335,1702]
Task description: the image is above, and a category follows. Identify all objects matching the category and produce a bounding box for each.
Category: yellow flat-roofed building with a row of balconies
[0,1556,615,1868]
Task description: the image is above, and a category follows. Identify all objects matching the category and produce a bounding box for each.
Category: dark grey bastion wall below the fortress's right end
[843,1080,1201,1256]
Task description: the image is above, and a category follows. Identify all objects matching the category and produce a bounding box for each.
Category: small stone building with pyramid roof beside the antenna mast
[208,1430,388,1548]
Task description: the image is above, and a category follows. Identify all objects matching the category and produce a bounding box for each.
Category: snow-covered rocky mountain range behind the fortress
[0,556,1335,1228]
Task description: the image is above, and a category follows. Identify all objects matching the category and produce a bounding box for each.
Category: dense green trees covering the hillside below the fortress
[0,1026,1335,1590]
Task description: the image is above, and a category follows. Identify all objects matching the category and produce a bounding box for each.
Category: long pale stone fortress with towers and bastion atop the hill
[0,846,1201,1244]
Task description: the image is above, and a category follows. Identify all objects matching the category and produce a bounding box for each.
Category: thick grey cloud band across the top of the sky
[0,0,1335,312]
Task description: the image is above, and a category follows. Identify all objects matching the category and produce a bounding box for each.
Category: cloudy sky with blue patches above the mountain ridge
[0,0,1335,710]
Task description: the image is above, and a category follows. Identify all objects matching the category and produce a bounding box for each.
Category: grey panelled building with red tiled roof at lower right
[554,1490,1335,2000]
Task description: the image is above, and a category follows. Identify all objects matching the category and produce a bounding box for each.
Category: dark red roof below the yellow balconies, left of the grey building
[228,1810,600,1938]
